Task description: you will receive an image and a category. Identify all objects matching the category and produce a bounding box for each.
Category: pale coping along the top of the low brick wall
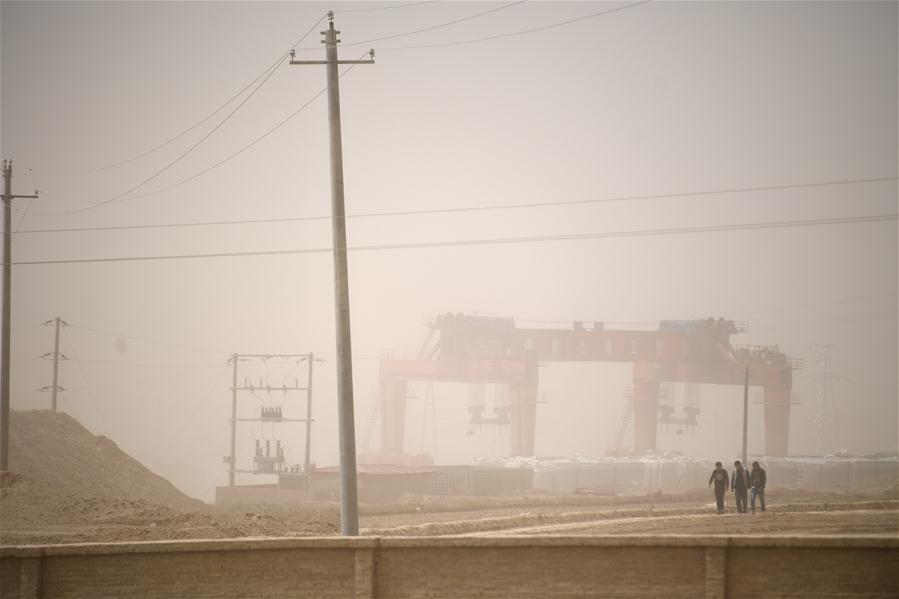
[0,535,899,557]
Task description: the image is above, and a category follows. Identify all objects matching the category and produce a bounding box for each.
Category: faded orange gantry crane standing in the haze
[379,314,801,459]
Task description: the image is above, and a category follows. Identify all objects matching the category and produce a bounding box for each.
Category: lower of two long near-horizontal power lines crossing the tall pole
[12,214,899,266]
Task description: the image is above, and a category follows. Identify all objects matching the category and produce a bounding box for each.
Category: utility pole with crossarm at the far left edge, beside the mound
[0,160,37,471]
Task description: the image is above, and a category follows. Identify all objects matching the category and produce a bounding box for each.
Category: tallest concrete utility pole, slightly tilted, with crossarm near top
[290,11,375,536]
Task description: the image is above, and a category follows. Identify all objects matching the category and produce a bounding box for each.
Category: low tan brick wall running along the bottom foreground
[0,536,899,599]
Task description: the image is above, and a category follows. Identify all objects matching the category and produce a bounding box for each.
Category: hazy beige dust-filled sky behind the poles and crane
[0,1,897,499]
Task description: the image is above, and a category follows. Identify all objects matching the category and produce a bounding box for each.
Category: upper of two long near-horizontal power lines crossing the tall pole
[17,175,897,235]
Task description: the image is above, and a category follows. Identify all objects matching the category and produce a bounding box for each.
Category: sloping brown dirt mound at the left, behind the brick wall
[5,410,207,511]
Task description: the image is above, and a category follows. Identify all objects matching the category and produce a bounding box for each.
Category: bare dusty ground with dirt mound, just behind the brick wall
[0,411,899,545]
